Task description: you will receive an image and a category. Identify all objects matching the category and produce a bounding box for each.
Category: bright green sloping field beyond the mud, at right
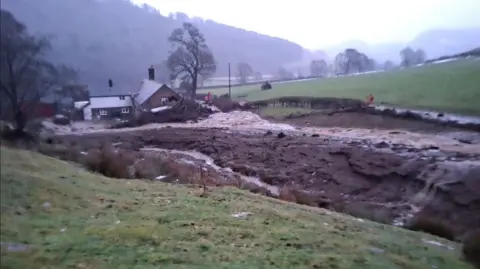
[203,59,480,115]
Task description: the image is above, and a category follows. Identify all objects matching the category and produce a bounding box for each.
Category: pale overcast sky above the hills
[133,0,480,49]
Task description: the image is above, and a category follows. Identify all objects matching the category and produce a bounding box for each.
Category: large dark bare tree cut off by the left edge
[0,10,59,133]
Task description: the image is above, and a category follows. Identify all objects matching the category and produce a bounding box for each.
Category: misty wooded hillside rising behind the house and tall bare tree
[2,0,303,91]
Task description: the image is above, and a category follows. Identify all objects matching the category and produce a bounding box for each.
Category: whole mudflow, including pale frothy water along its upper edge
[58,112,480,233]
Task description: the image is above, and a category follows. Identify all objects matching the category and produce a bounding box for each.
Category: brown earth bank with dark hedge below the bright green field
[251,97,480,132]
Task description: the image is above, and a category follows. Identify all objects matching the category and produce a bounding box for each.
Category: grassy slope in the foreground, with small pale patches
[1,148,471,269]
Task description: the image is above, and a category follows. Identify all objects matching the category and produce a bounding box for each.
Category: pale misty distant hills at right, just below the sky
[325,28,480,62]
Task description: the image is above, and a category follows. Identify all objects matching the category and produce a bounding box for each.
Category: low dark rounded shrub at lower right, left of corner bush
[406,215,455,240]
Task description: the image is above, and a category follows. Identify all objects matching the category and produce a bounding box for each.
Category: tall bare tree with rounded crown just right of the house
[167,23,217,99]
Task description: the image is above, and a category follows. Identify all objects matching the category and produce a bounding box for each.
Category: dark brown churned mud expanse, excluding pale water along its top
[59,128,480,232]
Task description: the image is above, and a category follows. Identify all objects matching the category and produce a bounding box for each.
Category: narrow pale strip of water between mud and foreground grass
[140,147,280,196]
